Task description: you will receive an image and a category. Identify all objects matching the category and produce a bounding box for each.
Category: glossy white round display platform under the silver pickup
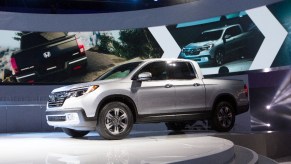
[0,131,275,164]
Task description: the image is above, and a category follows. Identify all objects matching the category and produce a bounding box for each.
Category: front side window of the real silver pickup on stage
[136,61,167,80]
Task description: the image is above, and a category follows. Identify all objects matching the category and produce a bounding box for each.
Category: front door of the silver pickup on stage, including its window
[135,61,175,115]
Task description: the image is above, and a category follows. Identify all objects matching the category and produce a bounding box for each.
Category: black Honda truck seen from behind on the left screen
[10,32,87,82]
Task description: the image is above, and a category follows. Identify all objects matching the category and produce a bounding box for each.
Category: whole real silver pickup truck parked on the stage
[46,59,249,139]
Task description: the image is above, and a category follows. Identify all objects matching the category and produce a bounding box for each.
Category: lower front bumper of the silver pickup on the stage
[46,109,97,130]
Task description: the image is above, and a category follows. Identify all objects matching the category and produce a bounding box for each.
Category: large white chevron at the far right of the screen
[246,6,288,70]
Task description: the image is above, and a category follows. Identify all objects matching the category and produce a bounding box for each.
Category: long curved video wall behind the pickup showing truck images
[0,1,291,83]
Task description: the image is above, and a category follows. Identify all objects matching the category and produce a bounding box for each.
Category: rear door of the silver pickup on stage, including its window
[168,61,205,113]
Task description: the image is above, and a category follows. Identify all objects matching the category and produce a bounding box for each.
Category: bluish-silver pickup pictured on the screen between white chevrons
[179,24,250,65]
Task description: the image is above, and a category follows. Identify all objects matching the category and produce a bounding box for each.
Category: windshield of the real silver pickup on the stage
[95,62,141,81]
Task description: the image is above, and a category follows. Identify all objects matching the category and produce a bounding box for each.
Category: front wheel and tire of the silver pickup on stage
[97,102,133,140]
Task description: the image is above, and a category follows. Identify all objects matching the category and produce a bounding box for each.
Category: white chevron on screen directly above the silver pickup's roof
[148,26,181,58]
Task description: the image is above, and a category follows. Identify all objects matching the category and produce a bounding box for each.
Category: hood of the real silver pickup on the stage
[52,79,121,92]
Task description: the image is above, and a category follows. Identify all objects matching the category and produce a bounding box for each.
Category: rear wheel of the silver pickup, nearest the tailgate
[212,101,235,132]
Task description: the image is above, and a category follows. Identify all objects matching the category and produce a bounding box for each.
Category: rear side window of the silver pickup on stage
[168,62,196,80]
